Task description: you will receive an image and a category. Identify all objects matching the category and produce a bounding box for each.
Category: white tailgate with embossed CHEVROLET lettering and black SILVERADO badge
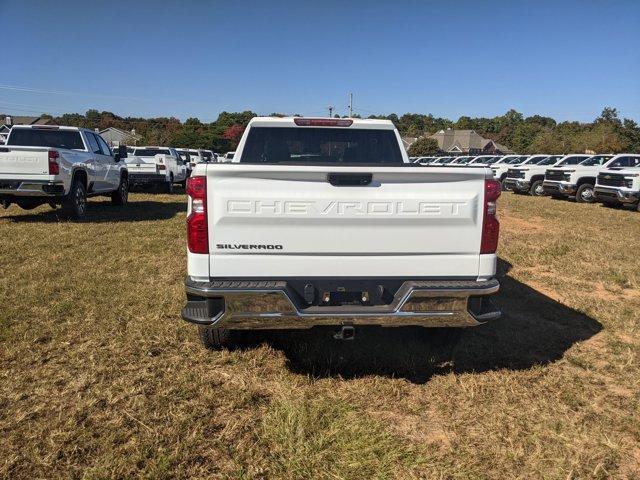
[207,164,487,278]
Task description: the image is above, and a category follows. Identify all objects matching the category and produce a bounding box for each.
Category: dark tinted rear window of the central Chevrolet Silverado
[240,127,403,164]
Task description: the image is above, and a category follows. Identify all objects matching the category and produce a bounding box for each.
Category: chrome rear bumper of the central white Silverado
[182,278,501,329]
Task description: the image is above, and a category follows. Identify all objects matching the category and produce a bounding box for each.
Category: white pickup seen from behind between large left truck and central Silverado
[127,146,189,193]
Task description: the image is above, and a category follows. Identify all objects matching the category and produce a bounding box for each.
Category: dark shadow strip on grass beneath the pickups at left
[5,195,187,223]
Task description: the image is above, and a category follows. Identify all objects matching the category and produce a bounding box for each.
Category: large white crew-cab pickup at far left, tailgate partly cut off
[0,125,129,218]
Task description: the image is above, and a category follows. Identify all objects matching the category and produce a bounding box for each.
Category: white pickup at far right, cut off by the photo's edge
[594,153,640,210]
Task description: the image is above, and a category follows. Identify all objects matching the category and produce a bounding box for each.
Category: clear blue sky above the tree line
[0,0,640,121]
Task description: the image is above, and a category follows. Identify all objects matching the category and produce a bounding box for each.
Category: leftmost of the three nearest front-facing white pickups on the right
[504,154,589,197]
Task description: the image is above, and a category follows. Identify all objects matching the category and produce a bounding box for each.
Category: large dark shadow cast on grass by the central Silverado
[244,260,602,383]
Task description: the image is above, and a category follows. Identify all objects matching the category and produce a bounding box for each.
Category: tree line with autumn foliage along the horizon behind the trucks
[46,107,640,153]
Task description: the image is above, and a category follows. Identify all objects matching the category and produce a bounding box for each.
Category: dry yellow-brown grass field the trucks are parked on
[0,189,640,479]
